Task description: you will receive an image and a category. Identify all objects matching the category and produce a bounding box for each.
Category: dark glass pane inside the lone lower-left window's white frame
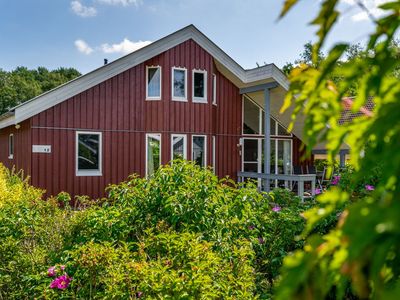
[78,134,100,170]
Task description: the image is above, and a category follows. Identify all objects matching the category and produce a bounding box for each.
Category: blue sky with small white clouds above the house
[0,0,384,73]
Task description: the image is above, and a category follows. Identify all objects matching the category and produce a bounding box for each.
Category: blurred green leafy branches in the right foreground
[277,0,400,299]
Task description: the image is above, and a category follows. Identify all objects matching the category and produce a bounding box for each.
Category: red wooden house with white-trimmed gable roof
[0,25,310,197]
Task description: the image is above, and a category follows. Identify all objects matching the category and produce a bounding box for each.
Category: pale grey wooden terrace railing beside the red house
[238,172,317,201]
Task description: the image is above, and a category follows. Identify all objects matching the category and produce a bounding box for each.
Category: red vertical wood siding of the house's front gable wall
[25,40,241,197]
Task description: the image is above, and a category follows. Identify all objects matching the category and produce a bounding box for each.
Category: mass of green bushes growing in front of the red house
[0,161,309,299]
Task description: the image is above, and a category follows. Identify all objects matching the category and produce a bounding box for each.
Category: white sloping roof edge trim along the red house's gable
[0,25,289,129]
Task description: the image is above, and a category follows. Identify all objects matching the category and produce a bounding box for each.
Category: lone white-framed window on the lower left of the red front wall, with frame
[76,132,102,176]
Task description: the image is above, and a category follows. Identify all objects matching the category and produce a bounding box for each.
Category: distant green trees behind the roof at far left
[0,67,81,114]
